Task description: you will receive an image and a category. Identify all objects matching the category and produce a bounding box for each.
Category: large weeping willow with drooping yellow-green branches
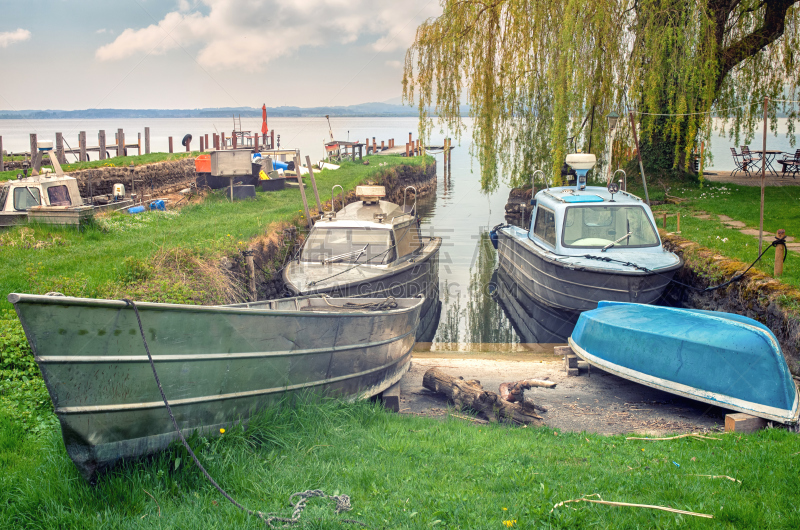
[403,0,800,189]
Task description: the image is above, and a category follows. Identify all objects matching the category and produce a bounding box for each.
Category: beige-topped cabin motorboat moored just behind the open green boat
[283,186,442,342]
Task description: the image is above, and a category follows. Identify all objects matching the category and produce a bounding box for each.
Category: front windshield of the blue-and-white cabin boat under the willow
[561,206,658,248]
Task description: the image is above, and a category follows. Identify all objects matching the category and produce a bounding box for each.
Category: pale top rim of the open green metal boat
[8,293,424,318]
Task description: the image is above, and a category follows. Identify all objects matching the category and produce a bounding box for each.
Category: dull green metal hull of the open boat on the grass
[9,294,422,480]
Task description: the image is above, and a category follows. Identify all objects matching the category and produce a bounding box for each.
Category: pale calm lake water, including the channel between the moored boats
[0,118,790,351]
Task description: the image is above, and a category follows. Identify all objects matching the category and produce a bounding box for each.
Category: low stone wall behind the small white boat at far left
[68,158,194,197]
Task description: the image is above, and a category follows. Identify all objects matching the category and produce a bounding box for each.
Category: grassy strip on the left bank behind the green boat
[0,156,432,309]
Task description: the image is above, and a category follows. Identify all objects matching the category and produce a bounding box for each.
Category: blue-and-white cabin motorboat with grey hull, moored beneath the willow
[491,153,683,312]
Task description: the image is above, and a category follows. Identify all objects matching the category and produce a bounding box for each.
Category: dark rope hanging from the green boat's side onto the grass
[122,298,367,528]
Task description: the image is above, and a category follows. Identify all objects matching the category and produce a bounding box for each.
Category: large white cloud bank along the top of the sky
[95,0,441,71]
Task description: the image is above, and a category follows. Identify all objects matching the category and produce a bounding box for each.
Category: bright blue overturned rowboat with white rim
[569,301,800,423]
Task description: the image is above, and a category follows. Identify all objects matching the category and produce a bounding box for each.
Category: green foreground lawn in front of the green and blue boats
[0,402,800,529]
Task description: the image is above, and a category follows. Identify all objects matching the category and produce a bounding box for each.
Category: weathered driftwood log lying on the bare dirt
[422,368,542,423]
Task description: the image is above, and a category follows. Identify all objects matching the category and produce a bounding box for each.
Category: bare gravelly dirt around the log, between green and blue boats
[400,354,727,435]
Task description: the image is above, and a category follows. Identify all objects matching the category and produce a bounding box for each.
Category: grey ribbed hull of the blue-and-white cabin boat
[497,230,682,312]
